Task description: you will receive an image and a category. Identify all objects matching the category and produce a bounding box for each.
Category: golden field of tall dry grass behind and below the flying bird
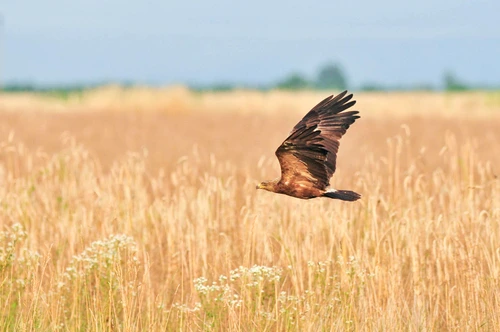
[0,87,500,331]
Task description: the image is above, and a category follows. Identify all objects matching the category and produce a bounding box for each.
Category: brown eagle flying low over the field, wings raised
[257,91,361,201]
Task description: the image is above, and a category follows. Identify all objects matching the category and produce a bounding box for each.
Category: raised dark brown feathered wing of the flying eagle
[276,91,359,189]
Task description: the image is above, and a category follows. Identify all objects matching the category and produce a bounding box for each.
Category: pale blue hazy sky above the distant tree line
[0,0,500,87]
